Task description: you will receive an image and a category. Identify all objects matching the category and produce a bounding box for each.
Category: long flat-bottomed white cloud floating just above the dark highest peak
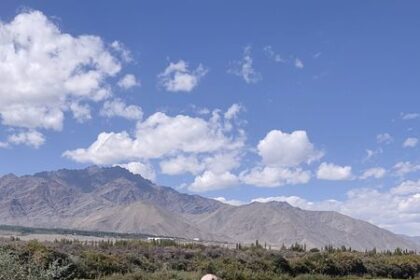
[64,106,245,164]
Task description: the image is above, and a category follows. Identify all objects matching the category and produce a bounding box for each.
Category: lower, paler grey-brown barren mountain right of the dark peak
[191,202,416,250]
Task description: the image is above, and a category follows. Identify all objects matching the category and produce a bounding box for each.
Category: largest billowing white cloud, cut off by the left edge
[0,11,121,134]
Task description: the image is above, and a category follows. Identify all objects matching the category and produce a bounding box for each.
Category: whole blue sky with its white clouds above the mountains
[0,1,420,234]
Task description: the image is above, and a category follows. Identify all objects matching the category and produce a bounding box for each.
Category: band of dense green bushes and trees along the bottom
[0,240,420,280]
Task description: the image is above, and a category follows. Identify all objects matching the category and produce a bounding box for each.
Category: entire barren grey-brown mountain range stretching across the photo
[0,166,420,250]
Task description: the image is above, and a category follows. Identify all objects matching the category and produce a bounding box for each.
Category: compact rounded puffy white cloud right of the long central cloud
[258,130,323,167]
